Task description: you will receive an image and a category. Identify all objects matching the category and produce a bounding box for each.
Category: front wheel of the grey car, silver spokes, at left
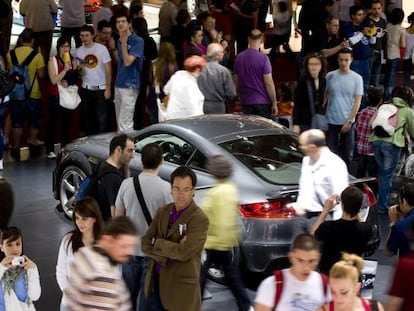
[59,165,86,218]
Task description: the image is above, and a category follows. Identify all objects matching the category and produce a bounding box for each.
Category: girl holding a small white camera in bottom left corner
[0,227,41,311]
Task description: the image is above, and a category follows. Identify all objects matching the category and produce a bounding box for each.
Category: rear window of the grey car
[220,135,303,185]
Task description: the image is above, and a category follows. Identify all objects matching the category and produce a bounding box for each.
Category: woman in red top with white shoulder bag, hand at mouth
[46,37,78,159]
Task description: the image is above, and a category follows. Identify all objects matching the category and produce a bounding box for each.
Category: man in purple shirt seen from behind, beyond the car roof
[234,29,277,118]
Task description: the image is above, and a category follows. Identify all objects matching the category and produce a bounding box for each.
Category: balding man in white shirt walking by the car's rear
[295,129,349,234]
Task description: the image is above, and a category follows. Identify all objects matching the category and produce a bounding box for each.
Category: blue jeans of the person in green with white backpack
[373,140,401,212]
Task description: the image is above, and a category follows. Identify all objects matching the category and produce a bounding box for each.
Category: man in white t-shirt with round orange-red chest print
[76,25,112,135]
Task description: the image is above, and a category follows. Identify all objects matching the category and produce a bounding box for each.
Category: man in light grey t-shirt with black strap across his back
[115,143,173,310]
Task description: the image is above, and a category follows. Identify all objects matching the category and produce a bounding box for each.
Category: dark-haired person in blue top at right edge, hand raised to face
[385,182,414,257]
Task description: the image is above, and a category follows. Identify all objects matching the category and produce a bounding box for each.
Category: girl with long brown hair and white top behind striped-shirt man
[56,197,103,311]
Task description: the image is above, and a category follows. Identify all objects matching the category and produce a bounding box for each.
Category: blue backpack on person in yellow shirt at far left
[9,50,37,100]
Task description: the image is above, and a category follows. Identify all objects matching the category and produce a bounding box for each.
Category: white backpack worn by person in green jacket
[371,103,399,137]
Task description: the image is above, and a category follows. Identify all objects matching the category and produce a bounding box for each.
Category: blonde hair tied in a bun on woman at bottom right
[329,253,364,283]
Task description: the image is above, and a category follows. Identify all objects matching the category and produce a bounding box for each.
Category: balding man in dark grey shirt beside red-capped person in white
[197,43,236,114]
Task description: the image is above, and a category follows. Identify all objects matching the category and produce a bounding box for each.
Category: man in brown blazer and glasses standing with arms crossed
[142,166,208,311]
